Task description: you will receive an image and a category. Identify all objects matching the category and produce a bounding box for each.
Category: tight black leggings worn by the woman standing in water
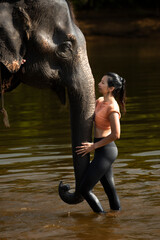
[80,138,120,212]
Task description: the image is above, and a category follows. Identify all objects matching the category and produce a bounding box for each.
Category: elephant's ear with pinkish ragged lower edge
[0,4,31,73]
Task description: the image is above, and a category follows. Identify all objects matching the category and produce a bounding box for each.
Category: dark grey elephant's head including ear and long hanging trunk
[0,0,95,204]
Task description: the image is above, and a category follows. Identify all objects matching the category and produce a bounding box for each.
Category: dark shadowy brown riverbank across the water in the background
[76,9,160,38]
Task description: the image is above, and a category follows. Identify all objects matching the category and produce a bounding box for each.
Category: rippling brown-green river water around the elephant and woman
[0,37,160,240]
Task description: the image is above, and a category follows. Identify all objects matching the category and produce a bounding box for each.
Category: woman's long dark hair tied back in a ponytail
[106,72,126,114]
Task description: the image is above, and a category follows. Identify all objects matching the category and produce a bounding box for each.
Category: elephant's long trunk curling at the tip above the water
[59,48,95,204]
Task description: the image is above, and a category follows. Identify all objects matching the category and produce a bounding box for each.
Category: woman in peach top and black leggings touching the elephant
[76,72,125,213]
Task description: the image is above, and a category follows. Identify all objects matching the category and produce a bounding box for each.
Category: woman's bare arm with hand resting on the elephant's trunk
[76,112,120,157]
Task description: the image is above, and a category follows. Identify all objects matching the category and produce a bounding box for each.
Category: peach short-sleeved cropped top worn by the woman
[94,97,121,130]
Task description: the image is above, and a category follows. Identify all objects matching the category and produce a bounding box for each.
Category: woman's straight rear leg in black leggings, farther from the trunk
[100,167,120,210]
